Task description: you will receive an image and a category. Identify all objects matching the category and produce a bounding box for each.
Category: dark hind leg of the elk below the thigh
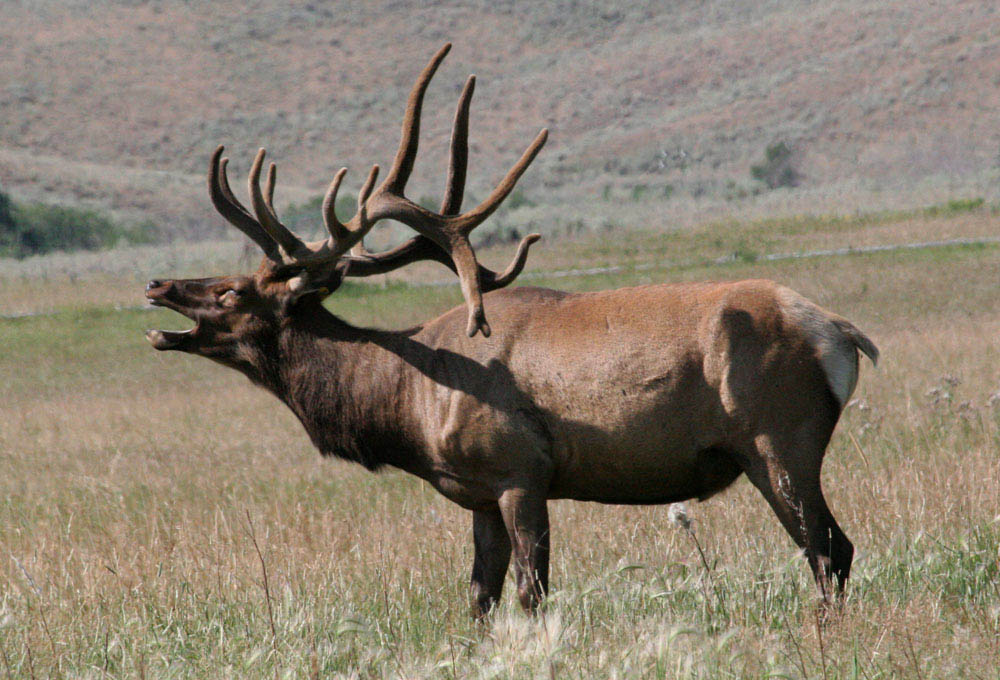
[744,435,854,600]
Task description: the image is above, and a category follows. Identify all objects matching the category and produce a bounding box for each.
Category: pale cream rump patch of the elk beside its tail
[777,287,858,409]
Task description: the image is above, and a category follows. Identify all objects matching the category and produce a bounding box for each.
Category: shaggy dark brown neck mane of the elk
[252,302,419,473]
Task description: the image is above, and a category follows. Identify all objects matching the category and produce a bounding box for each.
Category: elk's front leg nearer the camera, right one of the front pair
[500,489,549,613]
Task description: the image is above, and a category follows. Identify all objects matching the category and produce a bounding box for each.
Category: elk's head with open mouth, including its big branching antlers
[146,44,548,363]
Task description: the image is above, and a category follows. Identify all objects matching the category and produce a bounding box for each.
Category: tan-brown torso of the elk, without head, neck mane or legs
[292,281,872,509]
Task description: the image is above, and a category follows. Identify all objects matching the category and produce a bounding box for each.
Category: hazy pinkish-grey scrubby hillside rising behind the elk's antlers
[0,0,1000,242]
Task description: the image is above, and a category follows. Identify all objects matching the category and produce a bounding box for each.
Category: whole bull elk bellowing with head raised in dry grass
[146,45,878,615]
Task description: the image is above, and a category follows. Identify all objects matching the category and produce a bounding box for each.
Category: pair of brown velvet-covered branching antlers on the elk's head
[209,44,548,337]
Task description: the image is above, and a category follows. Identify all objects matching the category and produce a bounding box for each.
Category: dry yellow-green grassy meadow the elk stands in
[0,209,1000,680]
